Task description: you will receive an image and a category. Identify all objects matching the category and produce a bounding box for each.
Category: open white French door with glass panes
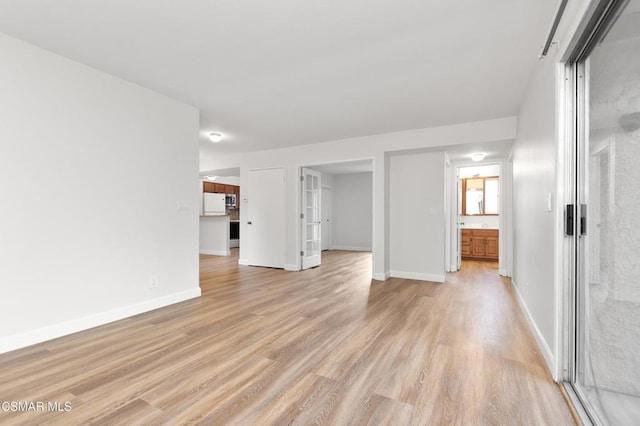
[301,168,322,269]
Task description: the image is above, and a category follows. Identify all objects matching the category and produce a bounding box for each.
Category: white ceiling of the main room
[0,0,557,153]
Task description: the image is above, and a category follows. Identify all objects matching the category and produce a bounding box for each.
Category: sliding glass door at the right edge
[571,0,640,425]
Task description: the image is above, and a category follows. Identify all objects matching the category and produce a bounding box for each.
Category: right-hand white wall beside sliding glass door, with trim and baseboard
[512,0,590,379]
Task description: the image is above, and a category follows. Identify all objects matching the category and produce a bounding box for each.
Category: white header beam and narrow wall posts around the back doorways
[200,117,516,279]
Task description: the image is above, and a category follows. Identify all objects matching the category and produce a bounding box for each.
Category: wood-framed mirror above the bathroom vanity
[462,176,499,216]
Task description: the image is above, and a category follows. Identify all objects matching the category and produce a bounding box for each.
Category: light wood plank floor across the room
[0,250,573,425]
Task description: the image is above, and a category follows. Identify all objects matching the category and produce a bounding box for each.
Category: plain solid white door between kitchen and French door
[246,169,286,268]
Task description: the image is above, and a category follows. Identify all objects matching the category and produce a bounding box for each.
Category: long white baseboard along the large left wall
[0,287,201,353]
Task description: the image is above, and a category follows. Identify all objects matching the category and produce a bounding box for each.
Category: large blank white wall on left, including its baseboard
[0,34,200,352]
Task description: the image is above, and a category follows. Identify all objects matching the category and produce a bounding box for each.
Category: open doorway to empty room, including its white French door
[299,159,373,269]
